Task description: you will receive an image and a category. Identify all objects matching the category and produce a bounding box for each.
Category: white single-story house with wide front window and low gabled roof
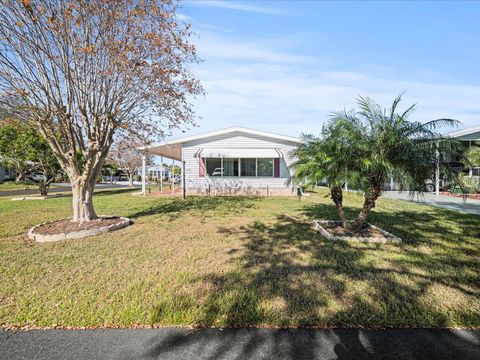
[142,127,301,195]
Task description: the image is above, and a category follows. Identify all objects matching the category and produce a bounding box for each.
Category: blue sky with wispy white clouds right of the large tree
[172,0,480,139]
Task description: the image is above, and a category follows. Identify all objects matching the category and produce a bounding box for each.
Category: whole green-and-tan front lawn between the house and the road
[0,191,480,327]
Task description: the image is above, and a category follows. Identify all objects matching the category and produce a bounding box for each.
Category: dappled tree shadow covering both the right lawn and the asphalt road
[148,204,480,359]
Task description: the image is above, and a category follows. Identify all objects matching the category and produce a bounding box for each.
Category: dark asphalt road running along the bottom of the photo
[0,328,480,360]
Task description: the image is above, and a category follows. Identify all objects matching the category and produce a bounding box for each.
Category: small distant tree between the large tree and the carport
[107,137,143,187]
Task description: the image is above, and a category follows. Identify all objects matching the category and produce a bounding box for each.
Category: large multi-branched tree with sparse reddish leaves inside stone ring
[0,0,203,221]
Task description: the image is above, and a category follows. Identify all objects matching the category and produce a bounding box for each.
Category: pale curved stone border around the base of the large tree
[27,215,131,242]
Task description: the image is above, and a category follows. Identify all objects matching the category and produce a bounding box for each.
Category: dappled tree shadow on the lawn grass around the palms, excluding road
[149,200,480,328]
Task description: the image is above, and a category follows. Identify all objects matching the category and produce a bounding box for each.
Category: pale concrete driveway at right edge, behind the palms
[382,191,480,215]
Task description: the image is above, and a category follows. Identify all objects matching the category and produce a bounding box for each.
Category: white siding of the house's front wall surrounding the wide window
[182,132,297,190]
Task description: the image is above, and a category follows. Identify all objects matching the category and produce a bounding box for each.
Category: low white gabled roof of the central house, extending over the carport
[139,126,302,160]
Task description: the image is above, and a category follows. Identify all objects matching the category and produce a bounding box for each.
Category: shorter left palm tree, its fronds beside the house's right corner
[291,114,361,227]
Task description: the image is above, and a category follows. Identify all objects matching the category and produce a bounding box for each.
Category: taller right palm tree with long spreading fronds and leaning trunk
[335,95,459,229]
